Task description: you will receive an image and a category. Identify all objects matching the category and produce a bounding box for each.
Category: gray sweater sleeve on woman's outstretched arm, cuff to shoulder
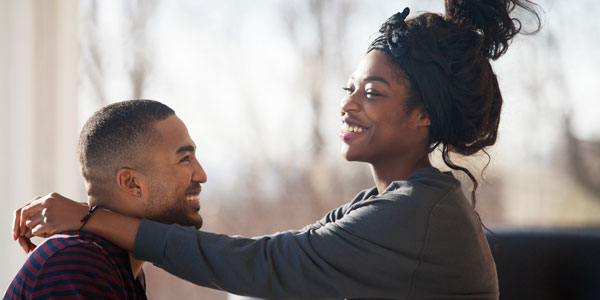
[134,198,428,299]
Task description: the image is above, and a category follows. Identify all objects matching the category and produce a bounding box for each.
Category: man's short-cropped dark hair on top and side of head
[77,100,175,184]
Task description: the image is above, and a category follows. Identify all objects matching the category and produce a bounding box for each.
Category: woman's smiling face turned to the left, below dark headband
[340,50,430,164]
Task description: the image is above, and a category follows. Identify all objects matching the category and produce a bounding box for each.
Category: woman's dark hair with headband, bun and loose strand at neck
[368,0,541,207]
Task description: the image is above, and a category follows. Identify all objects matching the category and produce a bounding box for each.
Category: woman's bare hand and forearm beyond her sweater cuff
[13,193,140,252]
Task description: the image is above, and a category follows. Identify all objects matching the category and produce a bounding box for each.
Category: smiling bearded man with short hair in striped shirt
[3,100,206,299]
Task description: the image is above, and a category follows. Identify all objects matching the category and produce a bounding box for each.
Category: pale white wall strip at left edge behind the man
[0,0,85,294]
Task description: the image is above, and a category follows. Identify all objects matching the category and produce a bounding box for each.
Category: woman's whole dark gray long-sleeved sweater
[134,168,498,299]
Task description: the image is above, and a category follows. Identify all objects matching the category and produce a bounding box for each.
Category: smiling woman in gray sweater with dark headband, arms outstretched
[15,0,539,299]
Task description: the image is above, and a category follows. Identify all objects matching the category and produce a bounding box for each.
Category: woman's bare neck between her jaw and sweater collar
[371,155,431,194]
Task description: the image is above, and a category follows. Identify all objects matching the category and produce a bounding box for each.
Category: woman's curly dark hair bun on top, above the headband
[445,0,541,59]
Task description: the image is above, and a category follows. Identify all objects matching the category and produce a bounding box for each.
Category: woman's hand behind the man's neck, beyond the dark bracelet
[12,193,88,253]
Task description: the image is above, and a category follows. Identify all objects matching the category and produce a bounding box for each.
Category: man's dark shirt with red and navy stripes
[2,231,146,300]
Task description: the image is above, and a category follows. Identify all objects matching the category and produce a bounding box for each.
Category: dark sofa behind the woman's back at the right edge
[487,228,600,300]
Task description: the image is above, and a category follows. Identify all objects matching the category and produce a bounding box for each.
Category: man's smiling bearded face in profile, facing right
[143,115,206,228]
